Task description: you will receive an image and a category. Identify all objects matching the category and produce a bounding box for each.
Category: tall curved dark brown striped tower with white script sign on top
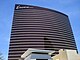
[8,4,77,60]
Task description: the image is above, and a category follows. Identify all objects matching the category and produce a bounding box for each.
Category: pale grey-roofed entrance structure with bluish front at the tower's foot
[21,48,55,60]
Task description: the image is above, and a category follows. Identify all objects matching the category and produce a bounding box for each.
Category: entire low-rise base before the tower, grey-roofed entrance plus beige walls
[19,48,80,60]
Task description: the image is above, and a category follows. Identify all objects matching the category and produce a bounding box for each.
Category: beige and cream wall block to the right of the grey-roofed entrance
[52,50,80,60]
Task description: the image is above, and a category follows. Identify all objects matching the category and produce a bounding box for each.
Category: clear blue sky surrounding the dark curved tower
[0,0,80,60]
